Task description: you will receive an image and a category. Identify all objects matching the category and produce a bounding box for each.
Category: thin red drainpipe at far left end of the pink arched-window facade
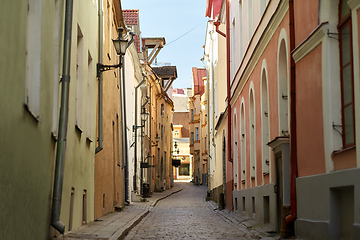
[226,0,234,208]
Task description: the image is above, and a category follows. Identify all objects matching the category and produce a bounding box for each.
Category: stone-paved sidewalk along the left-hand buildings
[56,184,182,240]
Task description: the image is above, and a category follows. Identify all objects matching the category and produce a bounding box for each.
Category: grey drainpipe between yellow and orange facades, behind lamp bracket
[95,0,104,154]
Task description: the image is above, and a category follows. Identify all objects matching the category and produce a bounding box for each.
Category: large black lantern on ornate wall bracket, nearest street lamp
[96,27,129,77]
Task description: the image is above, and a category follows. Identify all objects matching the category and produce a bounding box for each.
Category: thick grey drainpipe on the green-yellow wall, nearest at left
[51,0,73,234]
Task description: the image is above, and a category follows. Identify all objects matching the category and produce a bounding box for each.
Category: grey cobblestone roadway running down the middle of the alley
[125,183,276,240]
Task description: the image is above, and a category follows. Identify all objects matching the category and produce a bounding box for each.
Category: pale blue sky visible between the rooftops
[121,0,208,88]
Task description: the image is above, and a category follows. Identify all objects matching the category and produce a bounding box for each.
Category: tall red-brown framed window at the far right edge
[338,0,355,148]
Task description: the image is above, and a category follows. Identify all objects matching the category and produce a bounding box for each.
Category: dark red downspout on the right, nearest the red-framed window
[285,0,298,229]
